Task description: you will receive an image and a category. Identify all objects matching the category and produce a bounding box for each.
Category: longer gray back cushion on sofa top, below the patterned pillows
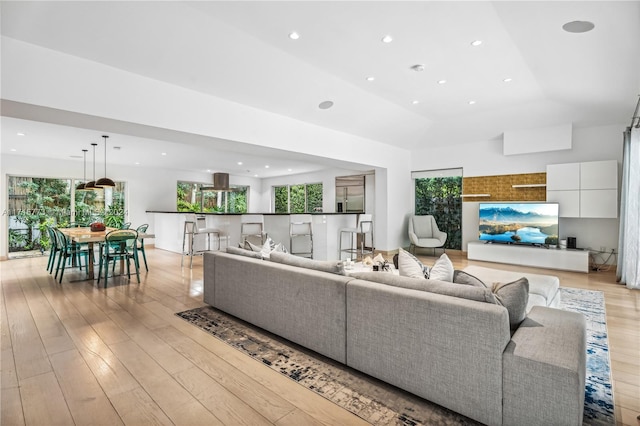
[350,272,497,304]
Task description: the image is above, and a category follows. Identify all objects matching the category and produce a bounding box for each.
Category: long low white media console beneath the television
[467,241,589,272]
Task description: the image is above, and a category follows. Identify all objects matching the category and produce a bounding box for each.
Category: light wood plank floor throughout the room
[0,249,640,426]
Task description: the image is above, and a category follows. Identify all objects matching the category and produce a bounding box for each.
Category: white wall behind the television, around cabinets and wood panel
[411,124,626,251]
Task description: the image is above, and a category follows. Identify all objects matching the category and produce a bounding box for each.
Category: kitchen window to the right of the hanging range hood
[273,183,322,213]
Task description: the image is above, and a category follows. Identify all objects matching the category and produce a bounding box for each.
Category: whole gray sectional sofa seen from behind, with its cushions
[204,252,586,426]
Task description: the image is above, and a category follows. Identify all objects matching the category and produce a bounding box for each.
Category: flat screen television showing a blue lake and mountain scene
[479,203,558,246]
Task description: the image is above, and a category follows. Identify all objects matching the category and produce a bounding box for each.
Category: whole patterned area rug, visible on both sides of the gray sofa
[176,288,615,425]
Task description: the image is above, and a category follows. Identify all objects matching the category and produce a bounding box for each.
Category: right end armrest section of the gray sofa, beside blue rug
[502,306,587,425]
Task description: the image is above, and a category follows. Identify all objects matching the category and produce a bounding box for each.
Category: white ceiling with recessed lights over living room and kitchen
[1,1,640,175]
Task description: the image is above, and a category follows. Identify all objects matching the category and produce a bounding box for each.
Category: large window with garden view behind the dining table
[7,176,126,253]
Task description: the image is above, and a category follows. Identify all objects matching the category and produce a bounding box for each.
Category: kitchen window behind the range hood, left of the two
[177,181,249,213]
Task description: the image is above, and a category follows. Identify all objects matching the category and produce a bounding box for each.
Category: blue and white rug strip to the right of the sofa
[560,287,616,425]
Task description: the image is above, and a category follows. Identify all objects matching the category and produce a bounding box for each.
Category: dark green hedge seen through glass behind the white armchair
[415,176,462,250]
